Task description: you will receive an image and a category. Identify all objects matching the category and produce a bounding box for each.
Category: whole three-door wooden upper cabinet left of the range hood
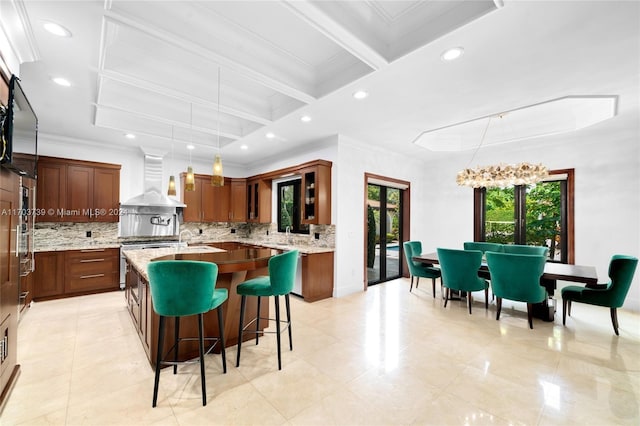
[36,157,120,222]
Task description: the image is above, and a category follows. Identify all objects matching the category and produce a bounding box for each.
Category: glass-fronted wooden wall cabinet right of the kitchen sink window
[300,160,331,225]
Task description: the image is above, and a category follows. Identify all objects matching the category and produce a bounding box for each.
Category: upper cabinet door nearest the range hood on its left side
[90,168,120,222]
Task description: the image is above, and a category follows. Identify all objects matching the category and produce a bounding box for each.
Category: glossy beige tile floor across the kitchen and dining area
[0,279,640,426]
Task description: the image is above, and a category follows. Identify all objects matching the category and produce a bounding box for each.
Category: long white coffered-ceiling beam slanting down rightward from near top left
[104,10,316,104]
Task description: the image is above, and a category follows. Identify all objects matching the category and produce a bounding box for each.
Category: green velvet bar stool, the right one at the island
[236,250,298,370]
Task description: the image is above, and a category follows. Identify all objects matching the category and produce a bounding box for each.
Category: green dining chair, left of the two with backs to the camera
[437,248,489,314]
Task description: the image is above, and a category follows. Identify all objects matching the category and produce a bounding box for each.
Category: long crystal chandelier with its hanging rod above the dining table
[456,114,549,188]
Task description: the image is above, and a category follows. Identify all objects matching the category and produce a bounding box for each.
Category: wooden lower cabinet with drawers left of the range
[33,248,120,301]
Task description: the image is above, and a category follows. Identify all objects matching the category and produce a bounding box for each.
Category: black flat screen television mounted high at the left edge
[0,75,38,178]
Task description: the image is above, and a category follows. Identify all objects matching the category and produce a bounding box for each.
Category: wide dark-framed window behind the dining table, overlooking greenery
[474,169,574,263]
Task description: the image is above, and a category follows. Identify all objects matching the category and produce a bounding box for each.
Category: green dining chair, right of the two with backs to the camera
[486,251,547,328]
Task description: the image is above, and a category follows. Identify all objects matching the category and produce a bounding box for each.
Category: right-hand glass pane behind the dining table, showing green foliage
[526,181,563,260]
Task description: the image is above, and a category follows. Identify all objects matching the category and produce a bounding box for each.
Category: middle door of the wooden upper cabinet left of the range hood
[64,165,93,222]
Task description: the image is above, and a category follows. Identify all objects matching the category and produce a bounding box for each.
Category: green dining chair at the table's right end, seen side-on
[562,254,638,336]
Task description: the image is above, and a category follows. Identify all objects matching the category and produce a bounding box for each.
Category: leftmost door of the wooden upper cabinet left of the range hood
[35,161,67,222]
